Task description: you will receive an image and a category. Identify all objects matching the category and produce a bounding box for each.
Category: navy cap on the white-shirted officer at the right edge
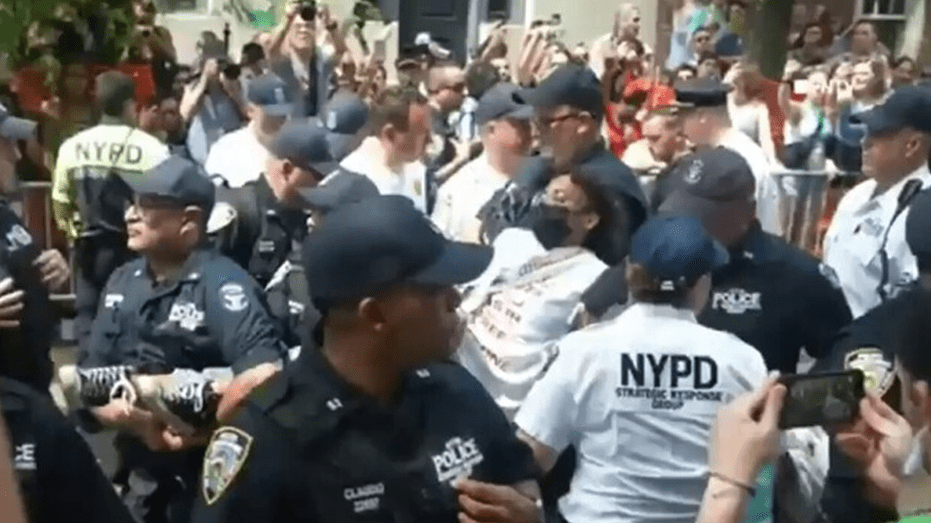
[850,85,931,134]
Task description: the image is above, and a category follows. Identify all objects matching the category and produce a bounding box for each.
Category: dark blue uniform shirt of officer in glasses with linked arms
[79,249,286,373]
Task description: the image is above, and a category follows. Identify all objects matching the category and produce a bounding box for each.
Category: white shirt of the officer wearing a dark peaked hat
[718,127,782,236]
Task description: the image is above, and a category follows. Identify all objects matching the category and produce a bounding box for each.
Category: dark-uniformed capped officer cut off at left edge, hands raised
[0,105,70,391]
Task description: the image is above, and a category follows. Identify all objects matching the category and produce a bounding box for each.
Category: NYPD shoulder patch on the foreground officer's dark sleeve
[201,427,252,505]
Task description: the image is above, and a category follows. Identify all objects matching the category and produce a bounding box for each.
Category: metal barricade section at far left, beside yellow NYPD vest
[19,182,75,311]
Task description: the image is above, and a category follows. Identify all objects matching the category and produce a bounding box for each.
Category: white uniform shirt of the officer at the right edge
[824,166,931,318]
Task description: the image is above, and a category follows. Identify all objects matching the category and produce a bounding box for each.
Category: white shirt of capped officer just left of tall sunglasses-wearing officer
[433,154,510,243]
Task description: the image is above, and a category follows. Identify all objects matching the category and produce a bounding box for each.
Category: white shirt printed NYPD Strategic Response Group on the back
[515,303,767,523]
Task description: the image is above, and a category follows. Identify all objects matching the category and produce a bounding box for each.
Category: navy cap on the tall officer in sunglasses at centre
[525,64,604,119]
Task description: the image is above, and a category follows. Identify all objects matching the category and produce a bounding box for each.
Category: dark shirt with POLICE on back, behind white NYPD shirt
[698,223,851,373]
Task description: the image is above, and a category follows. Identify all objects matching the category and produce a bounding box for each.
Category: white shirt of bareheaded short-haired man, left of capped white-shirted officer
[340,136,428,213]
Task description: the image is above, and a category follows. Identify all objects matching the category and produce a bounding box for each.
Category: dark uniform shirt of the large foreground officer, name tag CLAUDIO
[193,348,535,523]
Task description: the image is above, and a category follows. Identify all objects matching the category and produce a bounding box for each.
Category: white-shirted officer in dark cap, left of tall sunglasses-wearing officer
[433,83,533,243]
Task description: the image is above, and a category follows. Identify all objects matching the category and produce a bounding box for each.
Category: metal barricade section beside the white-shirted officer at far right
[771,168,860,254]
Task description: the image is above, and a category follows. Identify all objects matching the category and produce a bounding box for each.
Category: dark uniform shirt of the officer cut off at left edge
[0,199,58,390]
